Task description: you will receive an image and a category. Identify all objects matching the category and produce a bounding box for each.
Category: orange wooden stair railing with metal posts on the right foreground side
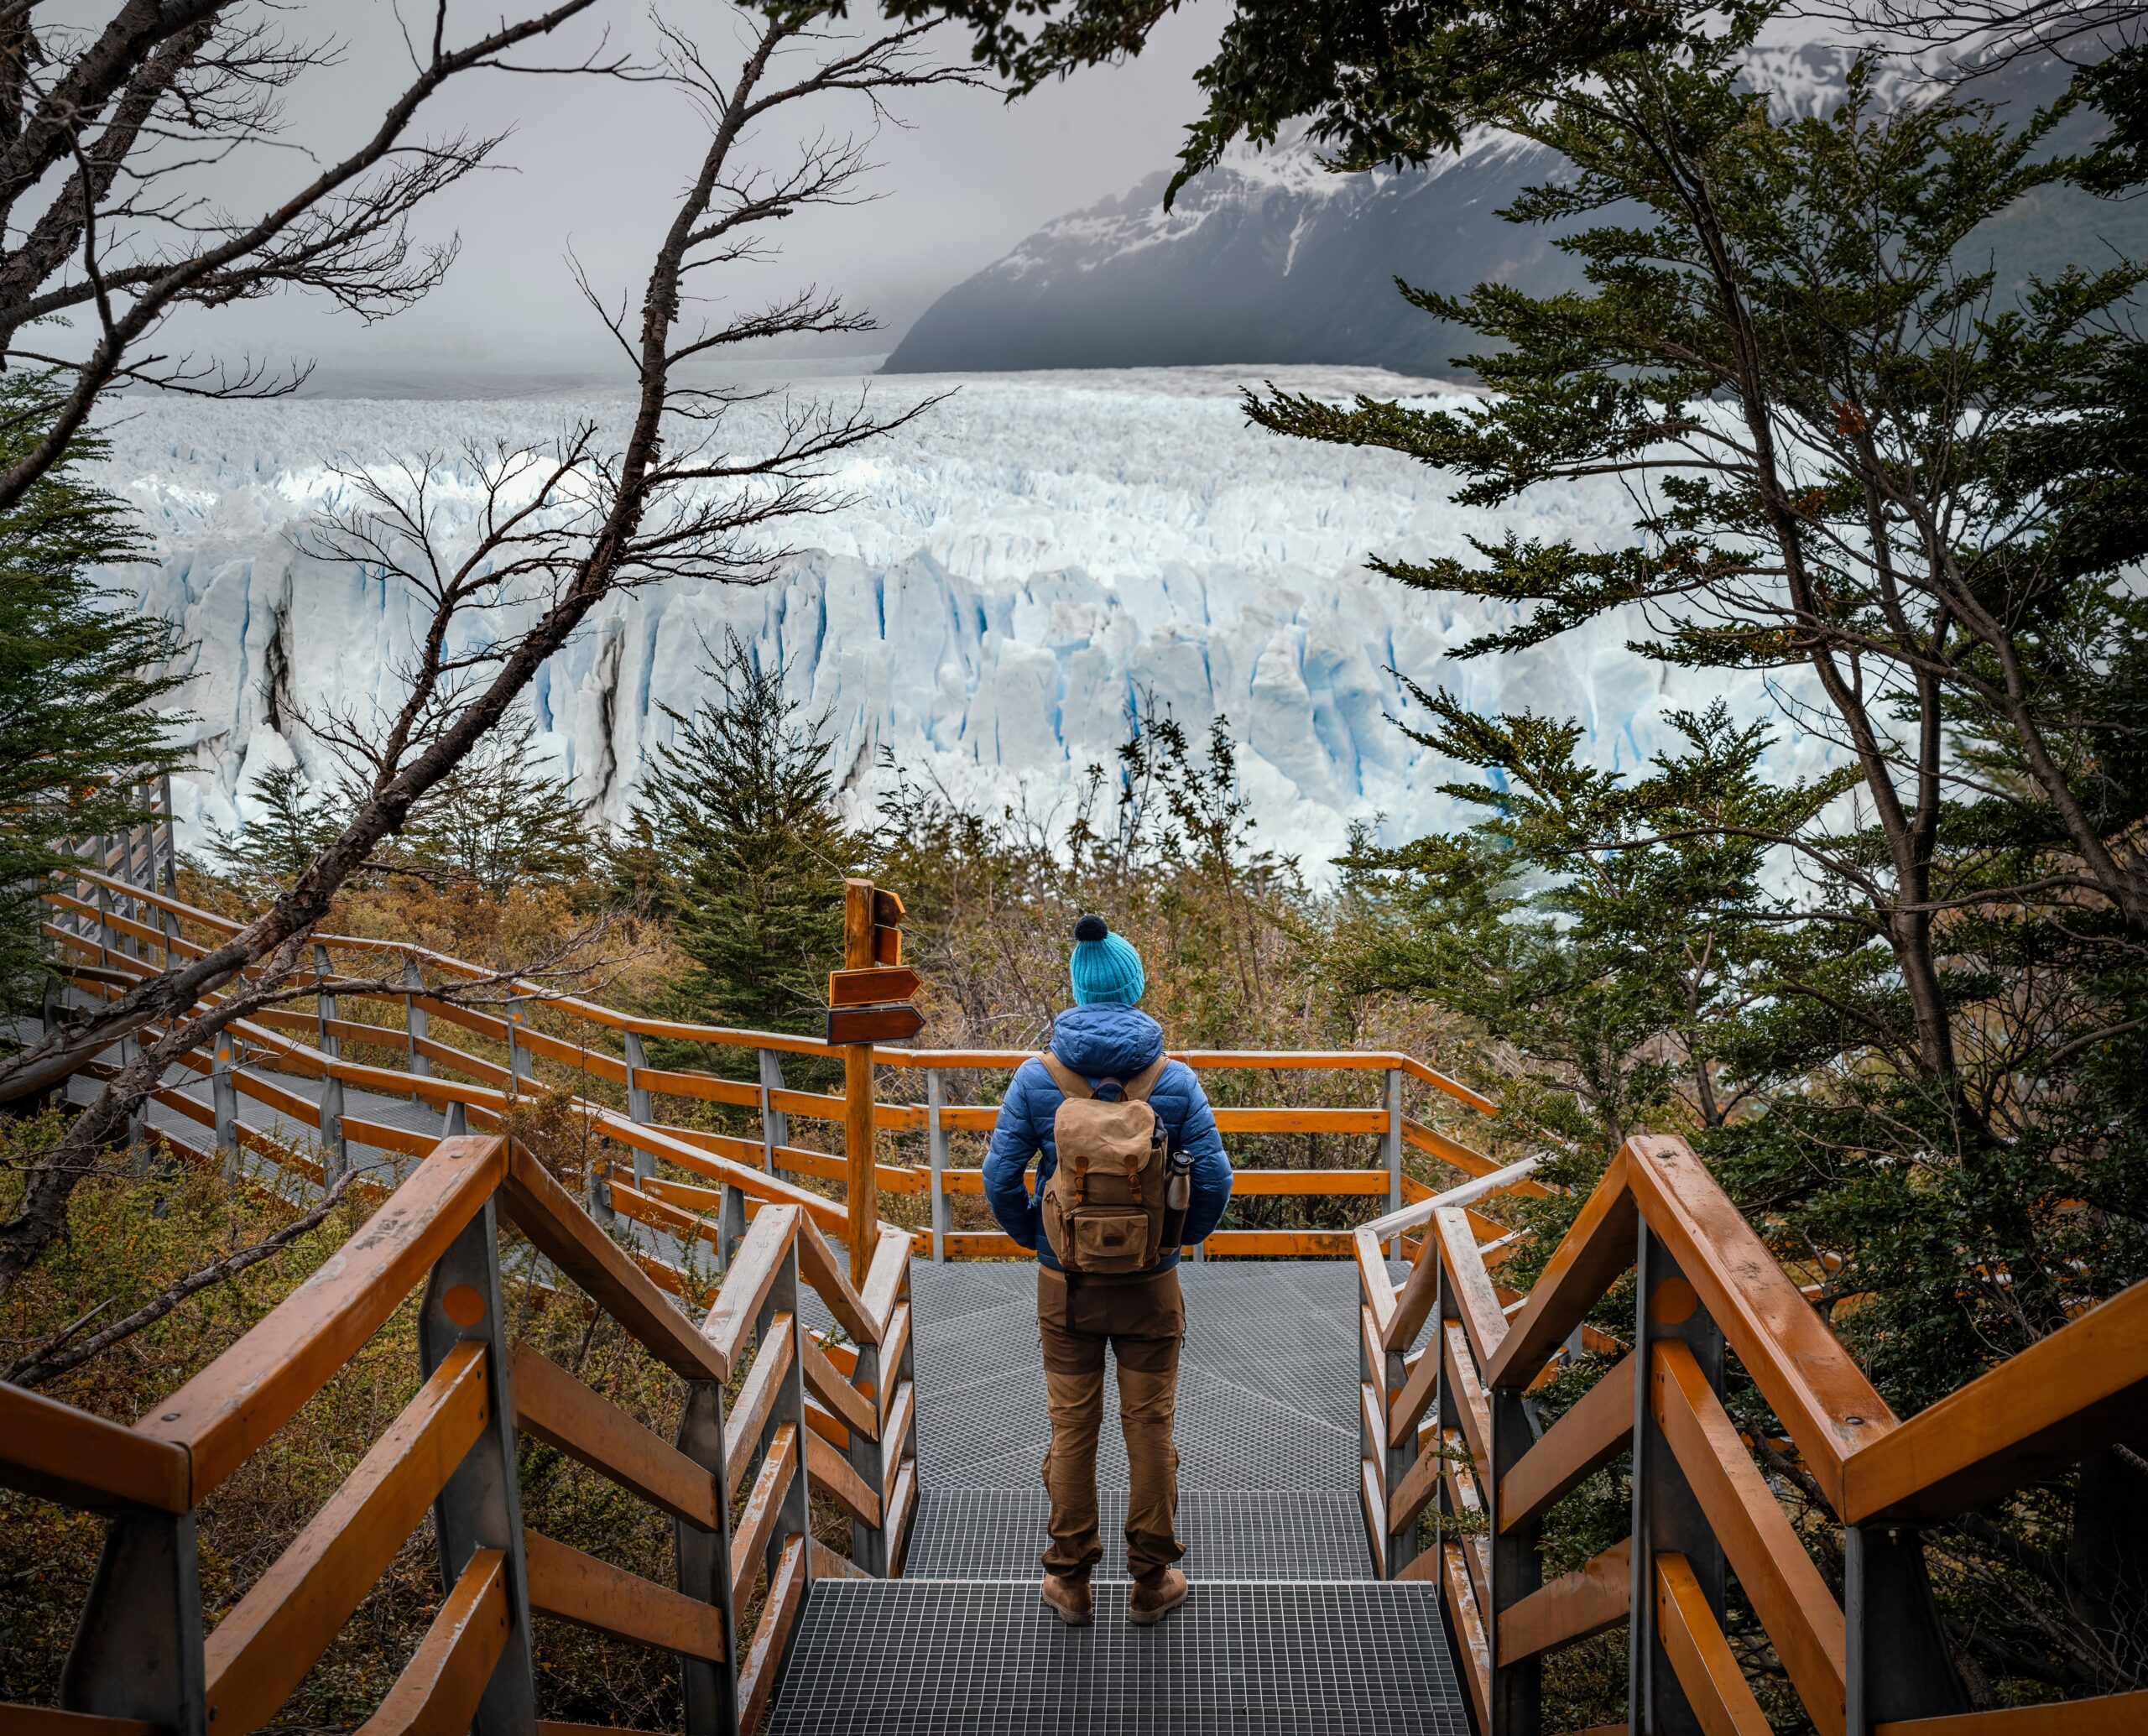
[1358,1137,2148,1736]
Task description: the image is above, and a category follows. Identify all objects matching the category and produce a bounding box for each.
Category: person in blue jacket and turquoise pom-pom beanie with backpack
[983,915,1231,1626]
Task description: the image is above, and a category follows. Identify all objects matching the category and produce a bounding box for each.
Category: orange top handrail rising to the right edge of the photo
[1843,1283,2148,1523]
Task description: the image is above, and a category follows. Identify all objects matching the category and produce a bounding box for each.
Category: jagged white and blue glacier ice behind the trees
[87,368,1823,874]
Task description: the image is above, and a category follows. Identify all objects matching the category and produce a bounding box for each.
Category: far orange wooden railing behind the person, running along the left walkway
[45,868,1535,1280]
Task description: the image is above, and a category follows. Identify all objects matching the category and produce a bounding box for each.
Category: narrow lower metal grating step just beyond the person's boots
[902,1484,1370,1583]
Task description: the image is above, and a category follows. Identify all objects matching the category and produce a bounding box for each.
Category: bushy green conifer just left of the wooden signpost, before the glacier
[617,633,866,1031]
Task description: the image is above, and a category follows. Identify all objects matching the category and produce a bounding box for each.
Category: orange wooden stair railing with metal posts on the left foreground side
[0,1134,917,1736]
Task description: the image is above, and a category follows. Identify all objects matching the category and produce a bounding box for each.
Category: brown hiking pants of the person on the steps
[1037,1265,1186,1579]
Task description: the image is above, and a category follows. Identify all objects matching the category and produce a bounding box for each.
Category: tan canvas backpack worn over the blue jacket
[1040,1055,1166,1276]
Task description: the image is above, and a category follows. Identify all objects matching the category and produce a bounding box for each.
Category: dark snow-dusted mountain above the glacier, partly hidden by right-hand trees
[887,41,2148,378]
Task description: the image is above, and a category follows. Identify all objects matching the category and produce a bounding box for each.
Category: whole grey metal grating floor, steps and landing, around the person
[767,1261,1469,1736]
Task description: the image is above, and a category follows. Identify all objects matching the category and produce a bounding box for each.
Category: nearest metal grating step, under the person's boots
[767,1579,1469,1736]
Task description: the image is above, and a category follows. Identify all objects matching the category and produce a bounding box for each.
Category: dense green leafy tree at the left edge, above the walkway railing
[0,374,180,1008]
